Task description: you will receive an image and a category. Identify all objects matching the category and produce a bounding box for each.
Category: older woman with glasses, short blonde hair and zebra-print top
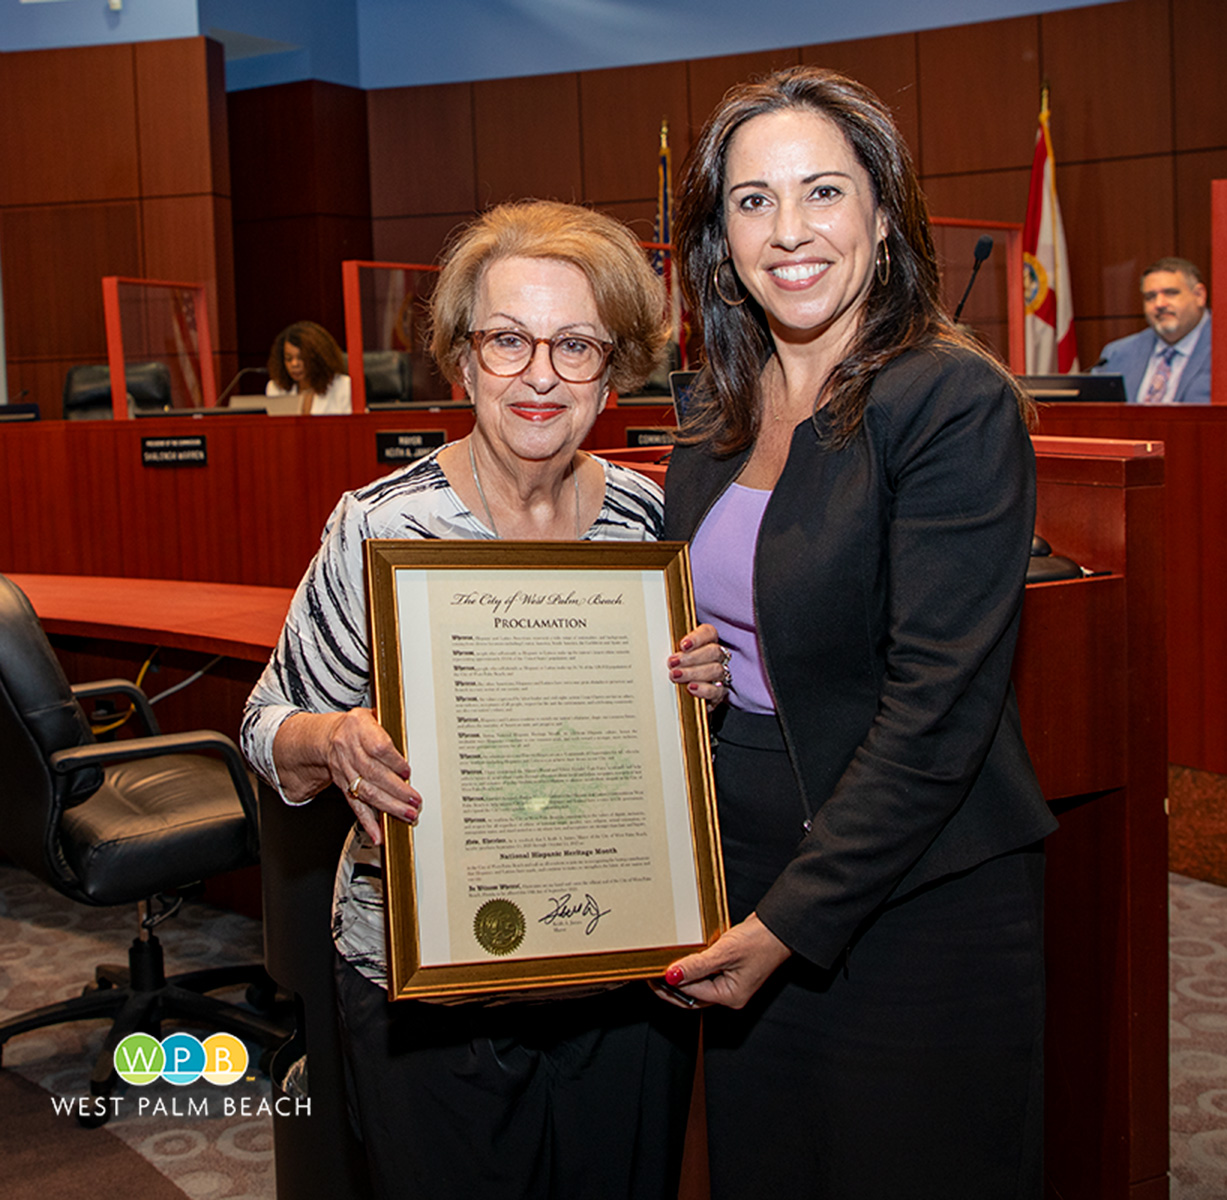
[243,201,701,1198]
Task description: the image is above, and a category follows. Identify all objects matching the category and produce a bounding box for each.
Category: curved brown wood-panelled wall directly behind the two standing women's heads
[343,0,1227,373]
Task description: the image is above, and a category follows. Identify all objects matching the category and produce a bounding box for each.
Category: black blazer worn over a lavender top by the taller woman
[665,347,1055,966]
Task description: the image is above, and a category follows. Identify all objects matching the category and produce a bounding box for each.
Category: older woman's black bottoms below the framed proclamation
[336,958,698,1200]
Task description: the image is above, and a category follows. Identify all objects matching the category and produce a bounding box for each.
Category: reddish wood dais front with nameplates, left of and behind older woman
[0,405,670,587]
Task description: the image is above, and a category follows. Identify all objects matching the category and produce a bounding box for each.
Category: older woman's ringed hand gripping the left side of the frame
[272,708,422,845]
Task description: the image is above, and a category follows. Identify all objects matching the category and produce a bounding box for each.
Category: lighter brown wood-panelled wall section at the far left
[0,38,234,416]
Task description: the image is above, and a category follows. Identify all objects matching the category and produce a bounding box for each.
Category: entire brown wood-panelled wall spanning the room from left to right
[0,0,1227,413]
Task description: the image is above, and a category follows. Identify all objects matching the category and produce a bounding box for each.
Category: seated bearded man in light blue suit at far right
[1091,258,1210,404]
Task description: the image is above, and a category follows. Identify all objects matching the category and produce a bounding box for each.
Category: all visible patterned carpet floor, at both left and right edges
[7,864,1227,1200]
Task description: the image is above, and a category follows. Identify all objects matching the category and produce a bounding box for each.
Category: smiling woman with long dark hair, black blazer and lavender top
[665,67,1055,1200]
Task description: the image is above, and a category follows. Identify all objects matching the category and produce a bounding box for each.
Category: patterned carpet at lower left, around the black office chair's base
[0,865,276,1200]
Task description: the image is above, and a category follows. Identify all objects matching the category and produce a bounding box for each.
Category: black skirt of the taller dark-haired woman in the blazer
[703,710,1044,1200]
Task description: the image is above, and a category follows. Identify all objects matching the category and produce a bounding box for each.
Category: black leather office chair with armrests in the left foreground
[0,575,288,1125]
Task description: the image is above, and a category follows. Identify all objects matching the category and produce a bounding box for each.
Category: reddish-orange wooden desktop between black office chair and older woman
[9,574,293,663]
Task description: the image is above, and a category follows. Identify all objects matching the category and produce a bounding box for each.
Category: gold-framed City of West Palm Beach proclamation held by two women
[366,540,728,1000]
